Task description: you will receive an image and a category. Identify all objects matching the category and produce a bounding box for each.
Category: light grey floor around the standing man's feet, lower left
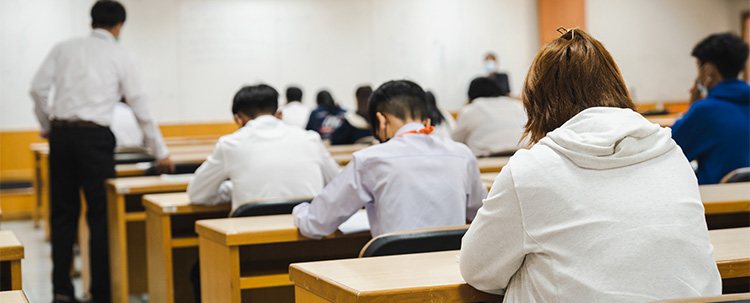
[0,220,147,303]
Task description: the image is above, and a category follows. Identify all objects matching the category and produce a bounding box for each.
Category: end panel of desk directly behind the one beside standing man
[146,211,174,303]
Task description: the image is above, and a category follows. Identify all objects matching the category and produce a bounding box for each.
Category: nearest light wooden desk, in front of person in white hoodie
[289,228,750,302]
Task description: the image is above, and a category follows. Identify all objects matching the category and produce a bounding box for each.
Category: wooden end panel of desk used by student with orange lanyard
[198,237,242,303]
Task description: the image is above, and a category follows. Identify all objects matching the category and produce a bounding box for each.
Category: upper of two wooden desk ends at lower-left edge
[0,230,23,292]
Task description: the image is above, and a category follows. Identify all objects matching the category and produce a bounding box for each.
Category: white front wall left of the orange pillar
[0,0,538,130]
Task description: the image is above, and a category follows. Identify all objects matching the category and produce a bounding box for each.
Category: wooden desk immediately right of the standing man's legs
[105,176,194,303]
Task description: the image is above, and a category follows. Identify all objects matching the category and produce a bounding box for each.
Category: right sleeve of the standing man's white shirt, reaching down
[121,53,169,159]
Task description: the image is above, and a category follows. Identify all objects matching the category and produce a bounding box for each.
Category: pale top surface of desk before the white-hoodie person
[290,228,750,302]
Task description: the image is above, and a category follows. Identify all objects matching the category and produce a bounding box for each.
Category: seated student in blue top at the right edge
[672,33,750,184]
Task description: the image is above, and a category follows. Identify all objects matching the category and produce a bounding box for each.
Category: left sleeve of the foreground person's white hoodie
[459,166,526,294]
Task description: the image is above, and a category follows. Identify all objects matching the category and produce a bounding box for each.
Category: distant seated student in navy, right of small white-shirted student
[305,90,346,143]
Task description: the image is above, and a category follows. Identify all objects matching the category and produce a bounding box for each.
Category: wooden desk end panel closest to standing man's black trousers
[107,192,128,303]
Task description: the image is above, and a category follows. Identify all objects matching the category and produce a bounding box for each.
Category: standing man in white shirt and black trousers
[31,1,174,302]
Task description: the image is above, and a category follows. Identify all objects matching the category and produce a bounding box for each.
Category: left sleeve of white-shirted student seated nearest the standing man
[187,141,231,205]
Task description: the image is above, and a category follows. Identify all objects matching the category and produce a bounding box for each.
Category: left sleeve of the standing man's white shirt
[29,47,57,131]
